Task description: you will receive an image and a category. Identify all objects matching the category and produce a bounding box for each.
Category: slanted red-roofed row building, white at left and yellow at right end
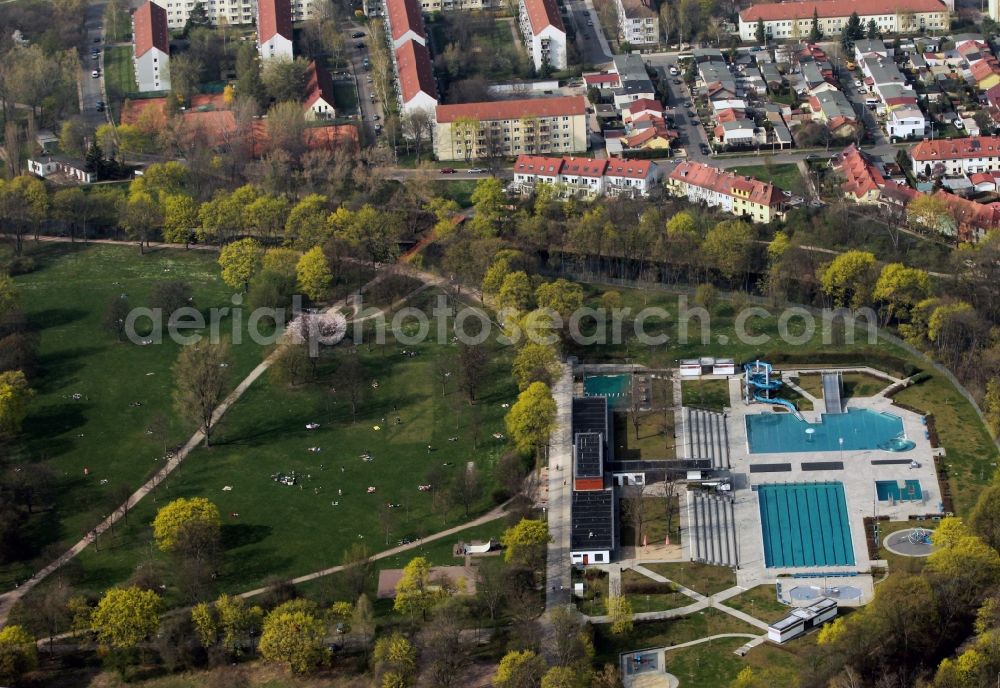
[667,161,786,222]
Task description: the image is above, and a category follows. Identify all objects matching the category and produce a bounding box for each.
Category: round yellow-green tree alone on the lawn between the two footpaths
[153,497,222,559]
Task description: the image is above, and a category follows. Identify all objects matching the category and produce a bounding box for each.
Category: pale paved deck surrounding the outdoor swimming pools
[727,377,940,589]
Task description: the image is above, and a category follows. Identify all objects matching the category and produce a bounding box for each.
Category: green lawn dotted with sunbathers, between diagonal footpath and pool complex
[31,290,515,601]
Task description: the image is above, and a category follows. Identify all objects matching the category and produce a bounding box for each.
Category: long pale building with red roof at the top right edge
[740,0,949,41]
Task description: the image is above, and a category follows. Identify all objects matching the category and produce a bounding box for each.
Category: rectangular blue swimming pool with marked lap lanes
[757,482,854,568]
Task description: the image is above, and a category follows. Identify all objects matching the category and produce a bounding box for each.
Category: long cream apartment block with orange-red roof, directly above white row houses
[434,96,587,160]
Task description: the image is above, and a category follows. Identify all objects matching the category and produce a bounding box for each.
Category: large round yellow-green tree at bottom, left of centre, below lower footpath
[260,600,329,674]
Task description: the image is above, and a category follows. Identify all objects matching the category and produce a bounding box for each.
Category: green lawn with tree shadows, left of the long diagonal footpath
[0,242,270,589]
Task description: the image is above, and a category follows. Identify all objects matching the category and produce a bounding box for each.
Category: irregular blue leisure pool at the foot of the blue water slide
[746,409,913,454]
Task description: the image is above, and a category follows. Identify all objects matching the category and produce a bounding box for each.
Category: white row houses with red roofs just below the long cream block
[513,155,660,197]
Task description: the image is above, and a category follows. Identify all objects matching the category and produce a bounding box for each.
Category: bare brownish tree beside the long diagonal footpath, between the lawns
[173,339,229,447]
